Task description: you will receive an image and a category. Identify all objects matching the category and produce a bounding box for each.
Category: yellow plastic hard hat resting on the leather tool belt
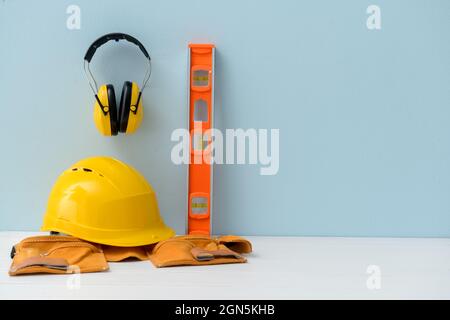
[41,157,175,247]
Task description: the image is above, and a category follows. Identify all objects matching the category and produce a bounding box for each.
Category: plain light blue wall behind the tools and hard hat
[0,0,450,236]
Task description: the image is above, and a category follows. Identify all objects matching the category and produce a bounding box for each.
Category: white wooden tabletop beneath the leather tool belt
[0,232,450,299]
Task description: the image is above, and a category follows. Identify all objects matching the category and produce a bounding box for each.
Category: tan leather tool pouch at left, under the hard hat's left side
[9,236,108,276]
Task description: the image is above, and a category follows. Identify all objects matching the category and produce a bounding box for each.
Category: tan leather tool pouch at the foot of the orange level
[149,235,252,268]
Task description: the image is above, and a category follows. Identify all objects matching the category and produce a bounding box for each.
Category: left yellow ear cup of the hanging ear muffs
[94,84,118,136]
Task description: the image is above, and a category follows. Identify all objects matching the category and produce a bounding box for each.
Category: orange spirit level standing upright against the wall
[187,44,215,235]
